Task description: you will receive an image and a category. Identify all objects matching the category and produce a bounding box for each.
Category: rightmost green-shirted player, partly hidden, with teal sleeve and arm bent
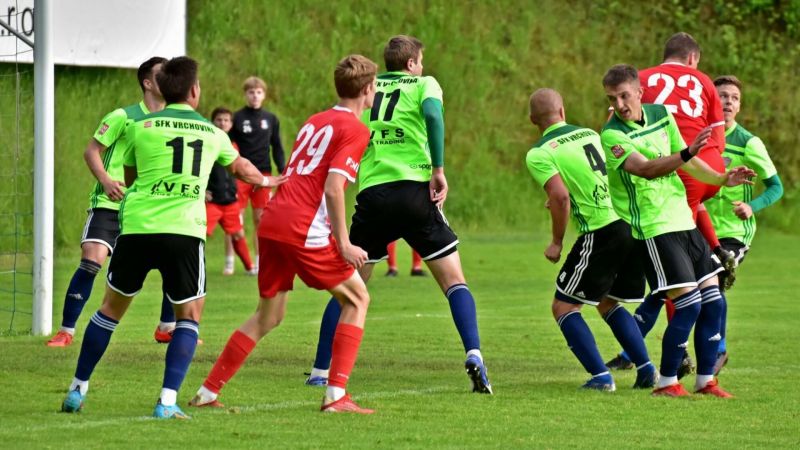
[705,75,783,373]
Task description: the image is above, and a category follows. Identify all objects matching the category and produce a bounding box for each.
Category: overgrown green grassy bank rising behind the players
[0,0,800,245]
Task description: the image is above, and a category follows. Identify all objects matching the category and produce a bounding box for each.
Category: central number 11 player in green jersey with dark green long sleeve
[306,35,492,394]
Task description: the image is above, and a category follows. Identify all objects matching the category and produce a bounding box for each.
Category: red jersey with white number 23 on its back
[639,63,725,159]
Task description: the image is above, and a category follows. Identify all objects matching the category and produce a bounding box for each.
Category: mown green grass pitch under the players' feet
[0,230,800,448]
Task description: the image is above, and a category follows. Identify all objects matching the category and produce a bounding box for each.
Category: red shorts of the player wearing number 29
[258,236,355,298]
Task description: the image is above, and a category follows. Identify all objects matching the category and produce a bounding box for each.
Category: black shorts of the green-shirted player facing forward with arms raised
[644,228,723,293]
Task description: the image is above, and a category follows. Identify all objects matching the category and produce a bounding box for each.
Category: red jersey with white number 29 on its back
[258,106,369,247]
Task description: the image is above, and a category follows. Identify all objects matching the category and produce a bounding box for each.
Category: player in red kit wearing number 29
[190,55,378,414]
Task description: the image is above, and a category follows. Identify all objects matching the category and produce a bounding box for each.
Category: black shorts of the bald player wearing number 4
[555,220,645,305]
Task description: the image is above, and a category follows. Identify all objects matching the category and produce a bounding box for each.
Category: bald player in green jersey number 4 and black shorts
[525,89,658,391]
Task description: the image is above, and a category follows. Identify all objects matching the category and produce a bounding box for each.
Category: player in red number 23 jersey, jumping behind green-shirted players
[639,32,735,270]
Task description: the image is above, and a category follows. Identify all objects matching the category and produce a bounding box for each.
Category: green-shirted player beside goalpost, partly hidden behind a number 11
[47,56,180,347]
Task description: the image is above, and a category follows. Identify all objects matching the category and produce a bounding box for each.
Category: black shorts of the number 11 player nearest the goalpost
[107,233,206,304]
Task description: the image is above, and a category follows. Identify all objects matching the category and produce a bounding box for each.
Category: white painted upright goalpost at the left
[32,0,55,335]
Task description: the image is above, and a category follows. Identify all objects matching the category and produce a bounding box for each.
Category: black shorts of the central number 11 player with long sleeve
[350,181,458,263]
